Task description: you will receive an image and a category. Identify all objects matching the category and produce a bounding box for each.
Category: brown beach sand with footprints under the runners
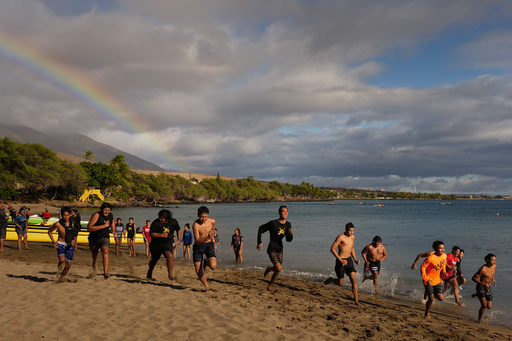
[0,242,512,340]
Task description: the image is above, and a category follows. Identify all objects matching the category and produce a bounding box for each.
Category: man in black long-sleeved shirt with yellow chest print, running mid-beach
[256,206,293,291]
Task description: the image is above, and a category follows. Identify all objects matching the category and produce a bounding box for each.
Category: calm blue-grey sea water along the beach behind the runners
[77,200,512,327]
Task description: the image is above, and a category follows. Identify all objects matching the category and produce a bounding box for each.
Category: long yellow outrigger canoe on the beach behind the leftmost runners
[5,222,144,245]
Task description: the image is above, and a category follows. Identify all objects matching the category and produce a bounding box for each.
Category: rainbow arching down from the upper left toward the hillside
[0,29,186,171]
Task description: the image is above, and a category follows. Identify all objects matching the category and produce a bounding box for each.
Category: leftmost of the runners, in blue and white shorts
[48,206,80,282]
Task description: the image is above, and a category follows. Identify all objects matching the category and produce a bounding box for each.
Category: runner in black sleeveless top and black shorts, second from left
[87,202,115,279]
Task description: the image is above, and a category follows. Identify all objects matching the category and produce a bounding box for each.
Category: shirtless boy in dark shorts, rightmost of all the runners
[472,253,496,323]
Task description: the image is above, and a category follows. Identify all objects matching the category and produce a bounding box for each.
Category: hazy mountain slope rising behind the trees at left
[0,126,164,171]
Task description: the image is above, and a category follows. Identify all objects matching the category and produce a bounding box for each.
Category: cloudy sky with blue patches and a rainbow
[0,0,512,195]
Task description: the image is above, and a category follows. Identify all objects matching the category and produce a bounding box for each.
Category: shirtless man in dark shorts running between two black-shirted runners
[192,206,217,290]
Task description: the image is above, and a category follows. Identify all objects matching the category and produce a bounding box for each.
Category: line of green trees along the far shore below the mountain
[0,137,335,205]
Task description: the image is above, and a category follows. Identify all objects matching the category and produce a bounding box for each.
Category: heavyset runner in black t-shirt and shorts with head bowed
[146,209,181,281]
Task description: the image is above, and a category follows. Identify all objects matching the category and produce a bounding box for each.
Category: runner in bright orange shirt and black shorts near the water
[421,240,446,318]
